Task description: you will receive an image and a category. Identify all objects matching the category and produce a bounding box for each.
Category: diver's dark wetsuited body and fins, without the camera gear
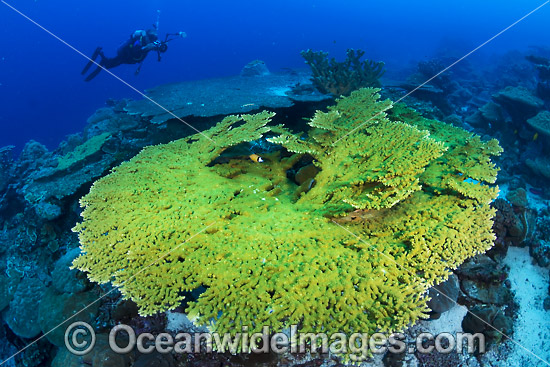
[81,31,157,82]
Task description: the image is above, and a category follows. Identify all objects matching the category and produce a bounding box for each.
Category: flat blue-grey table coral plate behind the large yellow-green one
[124,72,328,124]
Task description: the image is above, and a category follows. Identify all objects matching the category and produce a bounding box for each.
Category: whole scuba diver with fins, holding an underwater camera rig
[81,27,187,82]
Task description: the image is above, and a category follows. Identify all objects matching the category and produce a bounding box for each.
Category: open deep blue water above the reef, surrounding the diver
[0,0,550,150]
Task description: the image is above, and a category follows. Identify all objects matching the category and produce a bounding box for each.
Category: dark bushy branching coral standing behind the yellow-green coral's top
[301,49,384,96]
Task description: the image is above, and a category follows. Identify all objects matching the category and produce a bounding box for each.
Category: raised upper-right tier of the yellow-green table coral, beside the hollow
[270,89,446,216]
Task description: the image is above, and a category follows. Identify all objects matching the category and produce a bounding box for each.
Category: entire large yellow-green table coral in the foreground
[73,89,500,354]
